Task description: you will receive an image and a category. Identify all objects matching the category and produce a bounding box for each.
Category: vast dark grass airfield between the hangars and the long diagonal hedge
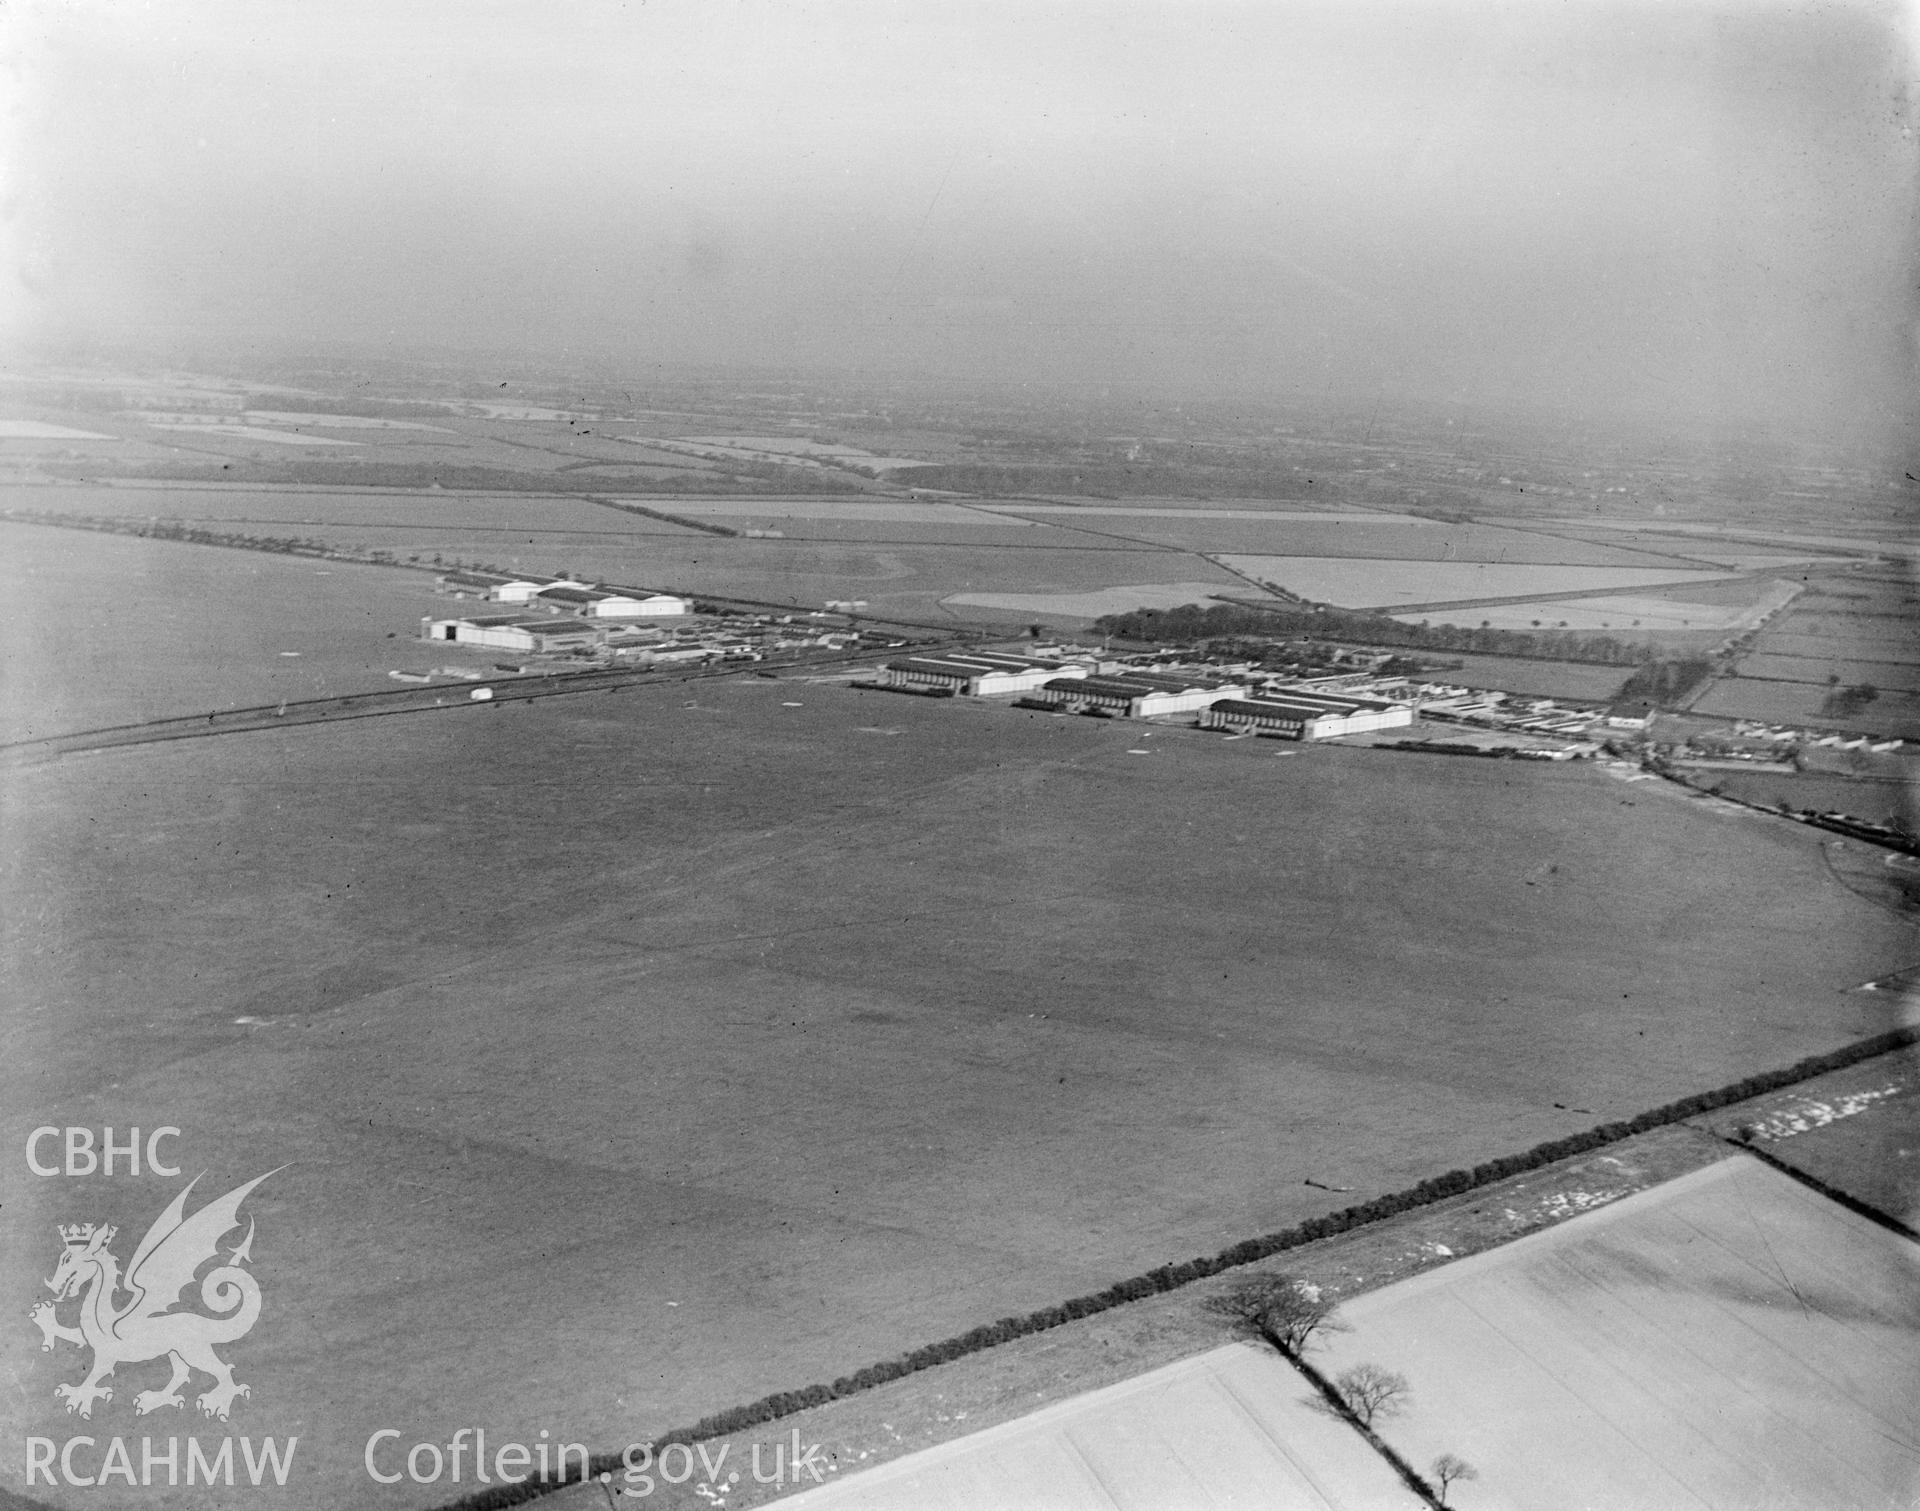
[0,678,1914,1505]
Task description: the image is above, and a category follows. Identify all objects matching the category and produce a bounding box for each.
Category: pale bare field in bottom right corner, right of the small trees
[1315,1158,1920,1511]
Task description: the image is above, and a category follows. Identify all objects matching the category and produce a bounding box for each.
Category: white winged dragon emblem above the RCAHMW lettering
[27,1165,284,1421]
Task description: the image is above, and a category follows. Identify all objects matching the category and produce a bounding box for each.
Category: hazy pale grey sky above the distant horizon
[0,0,1920,424]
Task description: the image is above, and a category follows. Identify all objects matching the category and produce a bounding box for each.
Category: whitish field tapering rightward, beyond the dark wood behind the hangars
[1221,555,1726,622]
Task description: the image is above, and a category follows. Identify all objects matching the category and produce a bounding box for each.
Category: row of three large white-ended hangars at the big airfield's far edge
[883,651,1413,739]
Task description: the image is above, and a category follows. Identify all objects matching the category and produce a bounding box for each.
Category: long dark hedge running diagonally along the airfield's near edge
[445,1027,1920,1511]
